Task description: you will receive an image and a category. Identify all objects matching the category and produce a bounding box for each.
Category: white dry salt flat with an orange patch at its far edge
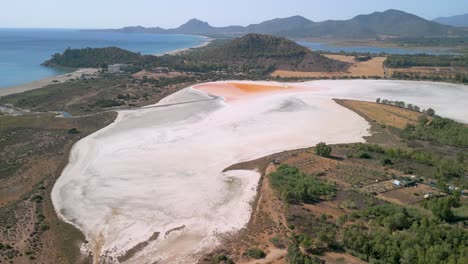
[52,80,468,263]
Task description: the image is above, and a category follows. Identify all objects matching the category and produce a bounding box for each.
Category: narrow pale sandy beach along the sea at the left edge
[0,68,99,97]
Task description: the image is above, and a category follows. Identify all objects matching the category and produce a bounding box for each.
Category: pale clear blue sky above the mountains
[0,0,468,28]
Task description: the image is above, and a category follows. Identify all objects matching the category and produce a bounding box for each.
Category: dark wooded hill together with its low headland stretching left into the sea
[44,34,350,75]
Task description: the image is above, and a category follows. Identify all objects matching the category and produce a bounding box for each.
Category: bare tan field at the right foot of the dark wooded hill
[271,54,386,78]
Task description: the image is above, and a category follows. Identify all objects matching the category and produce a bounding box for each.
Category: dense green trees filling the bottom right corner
[342,204,468,264]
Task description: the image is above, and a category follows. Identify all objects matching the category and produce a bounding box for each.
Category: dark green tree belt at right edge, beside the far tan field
[384,54,468,68]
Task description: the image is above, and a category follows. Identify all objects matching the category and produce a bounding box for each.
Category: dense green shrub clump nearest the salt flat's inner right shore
[269,164,335,203]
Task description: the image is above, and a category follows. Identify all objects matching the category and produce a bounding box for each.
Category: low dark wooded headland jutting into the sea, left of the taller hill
[43,47,142,68]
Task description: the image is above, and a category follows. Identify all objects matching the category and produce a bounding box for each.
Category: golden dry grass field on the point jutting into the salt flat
[336,100,422,128]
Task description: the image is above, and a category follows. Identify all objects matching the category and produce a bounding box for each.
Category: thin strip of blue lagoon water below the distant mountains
[298,41,455,55]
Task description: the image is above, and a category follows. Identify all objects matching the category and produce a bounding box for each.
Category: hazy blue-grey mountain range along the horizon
[87,9,468,38]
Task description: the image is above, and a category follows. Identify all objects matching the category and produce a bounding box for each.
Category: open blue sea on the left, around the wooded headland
[0,29,206,88]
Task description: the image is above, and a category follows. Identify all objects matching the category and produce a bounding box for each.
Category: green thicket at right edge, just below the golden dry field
[402,115,468,147]
